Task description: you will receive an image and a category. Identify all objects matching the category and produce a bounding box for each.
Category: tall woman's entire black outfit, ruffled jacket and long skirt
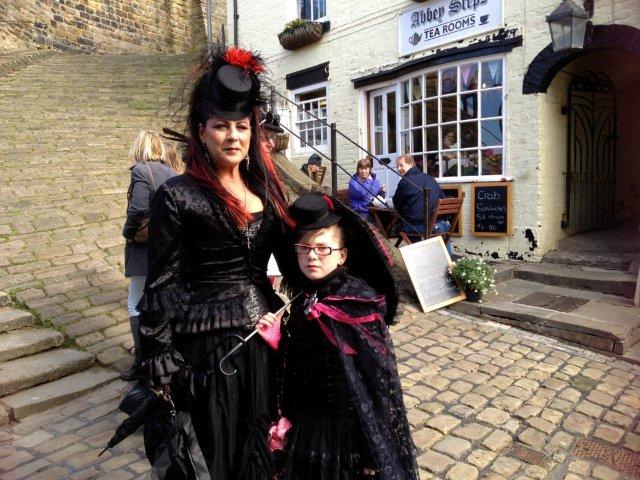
[138,175,284,480]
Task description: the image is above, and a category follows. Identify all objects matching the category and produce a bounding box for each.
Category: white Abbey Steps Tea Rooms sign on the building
[400,0,503,55]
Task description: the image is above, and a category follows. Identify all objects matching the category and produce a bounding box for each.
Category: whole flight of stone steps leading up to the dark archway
[451,232,640,363]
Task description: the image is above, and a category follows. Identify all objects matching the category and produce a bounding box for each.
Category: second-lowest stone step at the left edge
[0,348,95,396]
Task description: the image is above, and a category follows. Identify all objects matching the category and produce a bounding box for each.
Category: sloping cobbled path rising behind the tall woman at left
[0,52,190,376]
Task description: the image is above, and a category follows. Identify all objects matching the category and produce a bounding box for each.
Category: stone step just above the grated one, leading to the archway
[515,263,636,298]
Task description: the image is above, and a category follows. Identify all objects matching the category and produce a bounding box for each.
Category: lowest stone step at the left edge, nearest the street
[2,367,118,419]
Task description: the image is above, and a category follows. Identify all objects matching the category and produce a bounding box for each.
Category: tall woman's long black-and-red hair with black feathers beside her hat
[185,46,295,228]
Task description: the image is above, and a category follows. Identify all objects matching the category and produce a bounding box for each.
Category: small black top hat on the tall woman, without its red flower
[211,65,253,120]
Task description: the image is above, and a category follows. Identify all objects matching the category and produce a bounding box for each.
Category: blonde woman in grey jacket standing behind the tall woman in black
[120,130,176,380]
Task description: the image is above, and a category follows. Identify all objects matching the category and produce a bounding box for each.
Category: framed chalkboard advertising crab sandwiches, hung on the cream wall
[471,182,511,237]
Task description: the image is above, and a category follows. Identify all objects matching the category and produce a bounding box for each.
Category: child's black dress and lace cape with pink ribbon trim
[278,270,417,480]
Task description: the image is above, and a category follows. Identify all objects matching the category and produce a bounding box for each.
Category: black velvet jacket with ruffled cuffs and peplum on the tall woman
[138,175,285,385]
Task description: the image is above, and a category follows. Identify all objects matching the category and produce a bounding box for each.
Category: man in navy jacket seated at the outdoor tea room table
[393,155,451,249]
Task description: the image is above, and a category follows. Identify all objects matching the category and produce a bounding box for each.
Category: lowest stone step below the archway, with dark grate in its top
[449,279,640,355]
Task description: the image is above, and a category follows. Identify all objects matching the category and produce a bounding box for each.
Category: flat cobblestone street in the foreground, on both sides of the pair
[0,306,640,480]
